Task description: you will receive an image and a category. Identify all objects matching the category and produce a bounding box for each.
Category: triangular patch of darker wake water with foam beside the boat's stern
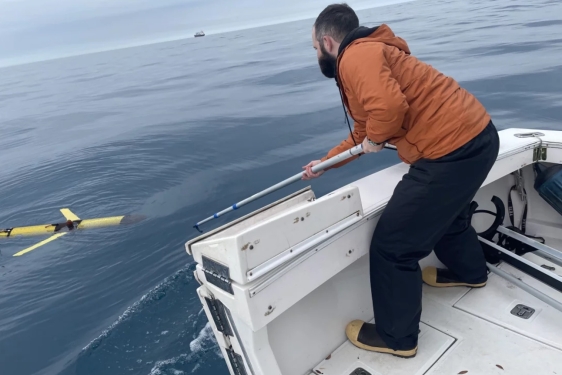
[73,264,226,375]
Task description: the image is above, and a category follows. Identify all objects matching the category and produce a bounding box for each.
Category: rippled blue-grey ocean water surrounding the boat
[0,0,562,375]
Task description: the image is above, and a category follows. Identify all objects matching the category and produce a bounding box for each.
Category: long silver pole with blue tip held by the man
[193,144,396,233]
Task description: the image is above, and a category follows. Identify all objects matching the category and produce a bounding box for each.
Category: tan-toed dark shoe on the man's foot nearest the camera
[345,320,418,358]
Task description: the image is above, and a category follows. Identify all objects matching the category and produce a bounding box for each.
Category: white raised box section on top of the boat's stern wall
[186,186,363,285]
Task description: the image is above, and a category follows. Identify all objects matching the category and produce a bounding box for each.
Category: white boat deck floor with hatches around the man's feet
[311,264,562,375]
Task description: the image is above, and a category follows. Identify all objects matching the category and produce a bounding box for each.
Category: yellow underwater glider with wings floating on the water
[0,208,145,257]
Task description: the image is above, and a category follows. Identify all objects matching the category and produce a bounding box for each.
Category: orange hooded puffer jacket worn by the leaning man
[322,24,490,168]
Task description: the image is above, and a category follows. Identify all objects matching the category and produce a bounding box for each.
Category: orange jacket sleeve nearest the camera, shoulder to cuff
[340,43,409,143]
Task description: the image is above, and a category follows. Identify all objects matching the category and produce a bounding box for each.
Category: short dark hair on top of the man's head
[314,3,359,44]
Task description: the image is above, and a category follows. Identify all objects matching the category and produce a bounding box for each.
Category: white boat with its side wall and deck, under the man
[186,129,562,375]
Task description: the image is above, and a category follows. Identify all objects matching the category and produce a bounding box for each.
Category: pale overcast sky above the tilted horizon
[0,0,404,66]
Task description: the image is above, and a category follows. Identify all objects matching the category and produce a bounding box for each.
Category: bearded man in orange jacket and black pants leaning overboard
[303,4,499,358]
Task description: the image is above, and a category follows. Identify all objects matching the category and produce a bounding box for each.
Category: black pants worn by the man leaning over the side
[370,121,499,350]
